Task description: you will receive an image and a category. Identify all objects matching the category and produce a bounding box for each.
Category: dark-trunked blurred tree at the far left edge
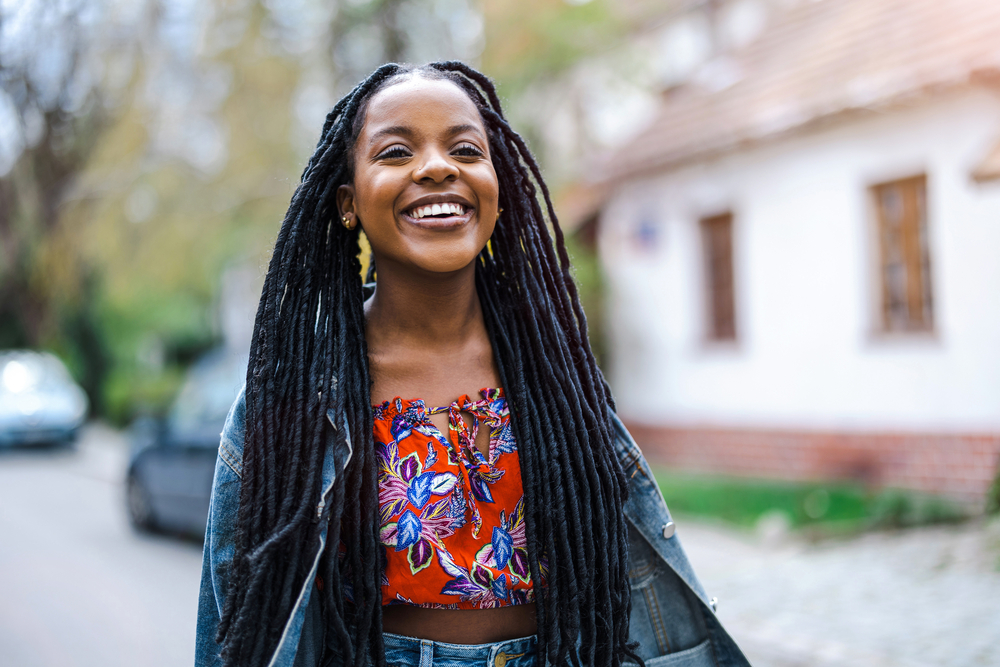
[0,2,155,407]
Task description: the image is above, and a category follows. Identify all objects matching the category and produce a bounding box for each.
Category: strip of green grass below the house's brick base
[653,468,968,532]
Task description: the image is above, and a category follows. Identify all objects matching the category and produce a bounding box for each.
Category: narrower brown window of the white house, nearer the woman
[700,213,736,340]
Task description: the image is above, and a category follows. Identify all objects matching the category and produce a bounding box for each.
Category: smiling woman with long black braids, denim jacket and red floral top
[196,62,745,667]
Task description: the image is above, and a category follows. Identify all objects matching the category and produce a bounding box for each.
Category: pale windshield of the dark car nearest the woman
[170,350,247,432]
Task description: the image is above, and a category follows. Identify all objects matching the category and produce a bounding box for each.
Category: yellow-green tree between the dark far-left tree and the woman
[10,0,482,420]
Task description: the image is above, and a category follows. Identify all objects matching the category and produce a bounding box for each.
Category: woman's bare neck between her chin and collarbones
[365,263,485,350]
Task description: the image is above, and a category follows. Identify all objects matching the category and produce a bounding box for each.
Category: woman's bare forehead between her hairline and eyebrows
[359,76,486,141]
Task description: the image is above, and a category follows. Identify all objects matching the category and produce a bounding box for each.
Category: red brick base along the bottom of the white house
[628,423,1000,507]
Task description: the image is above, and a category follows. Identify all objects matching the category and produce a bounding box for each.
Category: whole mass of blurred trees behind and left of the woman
[0,0,636,420]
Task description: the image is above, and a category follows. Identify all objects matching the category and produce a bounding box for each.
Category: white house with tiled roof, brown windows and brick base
[595,0,1000,503]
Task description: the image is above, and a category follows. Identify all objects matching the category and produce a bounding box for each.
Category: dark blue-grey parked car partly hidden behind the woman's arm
[125,349,247,536]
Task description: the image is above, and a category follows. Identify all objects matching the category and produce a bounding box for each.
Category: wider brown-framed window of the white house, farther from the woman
[872,176,933,331]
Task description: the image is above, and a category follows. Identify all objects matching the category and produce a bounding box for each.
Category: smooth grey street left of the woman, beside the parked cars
[0,427,201,667]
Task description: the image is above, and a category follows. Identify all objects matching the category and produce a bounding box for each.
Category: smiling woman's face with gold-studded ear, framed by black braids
[337,76,499,274]
